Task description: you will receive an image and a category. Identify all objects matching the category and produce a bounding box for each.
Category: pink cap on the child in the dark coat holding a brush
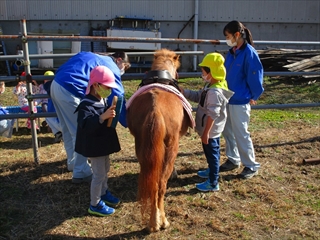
[86,66,117,95]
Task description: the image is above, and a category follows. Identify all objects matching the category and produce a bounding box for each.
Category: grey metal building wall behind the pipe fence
[0,0,320,70]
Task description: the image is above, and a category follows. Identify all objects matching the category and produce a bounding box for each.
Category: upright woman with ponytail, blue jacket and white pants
[220,21,264,178]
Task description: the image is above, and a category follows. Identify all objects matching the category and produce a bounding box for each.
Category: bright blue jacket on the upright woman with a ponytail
[224,43,264,105]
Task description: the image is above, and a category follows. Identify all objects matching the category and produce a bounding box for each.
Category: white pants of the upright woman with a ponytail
[222,103,260,171]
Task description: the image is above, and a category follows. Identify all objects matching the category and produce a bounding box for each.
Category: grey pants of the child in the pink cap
[90,155,110,206]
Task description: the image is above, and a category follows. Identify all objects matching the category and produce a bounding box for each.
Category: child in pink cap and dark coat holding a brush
[75,66,120,216]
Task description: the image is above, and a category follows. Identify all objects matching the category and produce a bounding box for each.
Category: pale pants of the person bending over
[50,80,92,178]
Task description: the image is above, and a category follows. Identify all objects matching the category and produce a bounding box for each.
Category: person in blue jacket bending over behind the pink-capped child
[50,52,130,183]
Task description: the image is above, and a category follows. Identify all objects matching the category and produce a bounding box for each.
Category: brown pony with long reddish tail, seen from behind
[127,49,190,232]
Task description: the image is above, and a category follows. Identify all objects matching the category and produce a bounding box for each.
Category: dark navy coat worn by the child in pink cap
[75,94,120,157]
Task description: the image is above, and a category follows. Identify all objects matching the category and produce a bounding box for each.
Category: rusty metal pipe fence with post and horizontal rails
[0,19,320,164]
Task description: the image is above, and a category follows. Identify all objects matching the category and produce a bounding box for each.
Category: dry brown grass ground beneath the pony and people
[0,78,320,240]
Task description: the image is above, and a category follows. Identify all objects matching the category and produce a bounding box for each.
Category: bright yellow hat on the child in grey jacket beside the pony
[199,53,227,81]
